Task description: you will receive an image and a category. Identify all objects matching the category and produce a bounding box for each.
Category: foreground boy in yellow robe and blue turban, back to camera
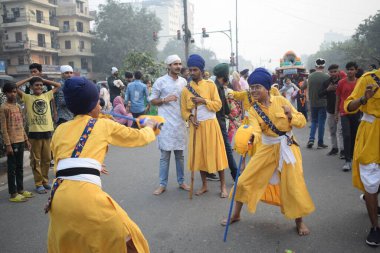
[45,77,156,253]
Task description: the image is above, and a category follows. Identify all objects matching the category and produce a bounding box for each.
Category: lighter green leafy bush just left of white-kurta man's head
[124,52,166,79]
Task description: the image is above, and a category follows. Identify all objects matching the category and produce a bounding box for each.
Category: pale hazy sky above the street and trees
[90,0,380,68]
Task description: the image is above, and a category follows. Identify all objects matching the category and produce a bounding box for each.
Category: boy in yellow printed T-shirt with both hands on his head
[16,76,61,194]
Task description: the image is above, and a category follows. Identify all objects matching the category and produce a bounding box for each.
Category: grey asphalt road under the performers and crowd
[0,127,378,253]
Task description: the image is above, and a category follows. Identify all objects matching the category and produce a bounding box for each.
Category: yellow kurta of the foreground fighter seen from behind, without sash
[48,115,155,253]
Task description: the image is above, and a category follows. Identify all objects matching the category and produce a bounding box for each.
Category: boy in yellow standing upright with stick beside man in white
[181,54,228,198]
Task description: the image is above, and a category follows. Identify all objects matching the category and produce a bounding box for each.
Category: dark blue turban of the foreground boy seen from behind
[63,76,99,115]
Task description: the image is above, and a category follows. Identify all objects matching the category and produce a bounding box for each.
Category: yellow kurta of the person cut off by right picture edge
[344,70,380,191]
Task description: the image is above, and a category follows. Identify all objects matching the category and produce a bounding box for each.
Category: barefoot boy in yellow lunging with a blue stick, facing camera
[222,68,315,236]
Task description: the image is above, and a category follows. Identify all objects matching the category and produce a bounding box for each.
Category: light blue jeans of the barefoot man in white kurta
[159,150,184,188]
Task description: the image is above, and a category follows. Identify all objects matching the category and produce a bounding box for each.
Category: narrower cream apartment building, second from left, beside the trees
[56,0,94,76]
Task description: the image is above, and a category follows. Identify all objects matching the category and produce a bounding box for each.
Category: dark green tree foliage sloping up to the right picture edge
[307,11,380,70]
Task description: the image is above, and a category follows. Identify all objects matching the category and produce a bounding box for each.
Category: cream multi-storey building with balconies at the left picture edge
[0,0,59,76]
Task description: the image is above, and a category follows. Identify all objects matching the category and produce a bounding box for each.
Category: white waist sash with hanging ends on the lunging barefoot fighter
[261,131,296,184]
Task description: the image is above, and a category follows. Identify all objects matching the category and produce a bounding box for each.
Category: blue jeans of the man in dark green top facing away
[309,107,327,145]
